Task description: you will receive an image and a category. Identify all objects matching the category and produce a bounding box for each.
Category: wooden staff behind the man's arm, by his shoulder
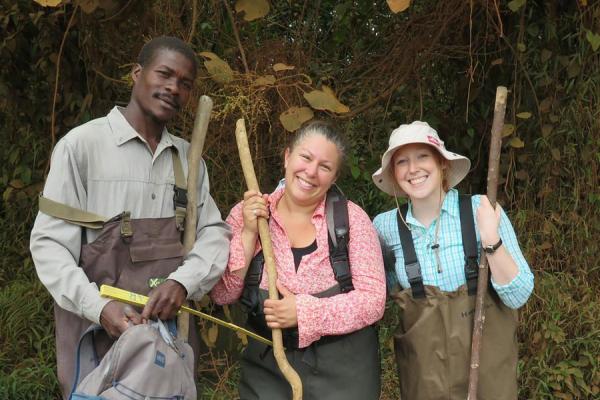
[177,96,213,342]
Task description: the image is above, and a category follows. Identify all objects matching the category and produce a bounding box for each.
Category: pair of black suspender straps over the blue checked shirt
[396,195,479,299]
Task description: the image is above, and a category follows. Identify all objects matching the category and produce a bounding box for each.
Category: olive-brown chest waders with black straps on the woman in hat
[393,195,518,400]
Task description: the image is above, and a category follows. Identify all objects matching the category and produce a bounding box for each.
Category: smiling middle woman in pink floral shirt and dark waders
[212,121,386,400]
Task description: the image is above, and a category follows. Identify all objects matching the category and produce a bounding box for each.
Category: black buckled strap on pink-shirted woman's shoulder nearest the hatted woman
[325,185,354,293]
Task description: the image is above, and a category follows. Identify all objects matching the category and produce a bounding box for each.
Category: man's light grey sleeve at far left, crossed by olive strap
[30,139,109,323]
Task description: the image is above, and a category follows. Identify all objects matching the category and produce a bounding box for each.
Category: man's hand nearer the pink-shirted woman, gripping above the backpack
[142,279,187,321]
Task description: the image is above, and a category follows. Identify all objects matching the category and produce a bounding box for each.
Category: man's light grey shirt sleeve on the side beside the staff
[168,162,231,300]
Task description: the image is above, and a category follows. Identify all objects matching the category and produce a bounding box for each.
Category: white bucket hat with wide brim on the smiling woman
[373,121,471,196]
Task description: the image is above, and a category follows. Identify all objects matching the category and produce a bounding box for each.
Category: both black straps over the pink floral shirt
[240,185,354,315]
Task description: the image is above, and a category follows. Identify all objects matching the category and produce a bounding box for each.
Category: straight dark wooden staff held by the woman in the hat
[467,86,507,400]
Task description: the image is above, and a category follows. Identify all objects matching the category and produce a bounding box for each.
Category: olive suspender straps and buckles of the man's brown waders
[39,146,187,231]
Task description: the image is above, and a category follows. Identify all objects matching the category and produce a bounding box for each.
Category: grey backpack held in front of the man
[70,321,196,400]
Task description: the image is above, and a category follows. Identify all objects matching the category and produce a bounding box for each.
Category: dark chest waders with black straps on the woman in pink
[239,186,380,400]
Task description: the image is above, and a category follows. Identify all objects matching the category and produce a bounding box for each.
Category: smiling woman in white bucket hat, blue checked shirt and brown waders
[373,121,533,400]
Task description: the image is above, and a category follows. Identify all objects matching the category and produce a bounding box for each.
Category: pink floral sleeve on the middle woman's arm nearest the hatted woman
[296,202,386,348]
